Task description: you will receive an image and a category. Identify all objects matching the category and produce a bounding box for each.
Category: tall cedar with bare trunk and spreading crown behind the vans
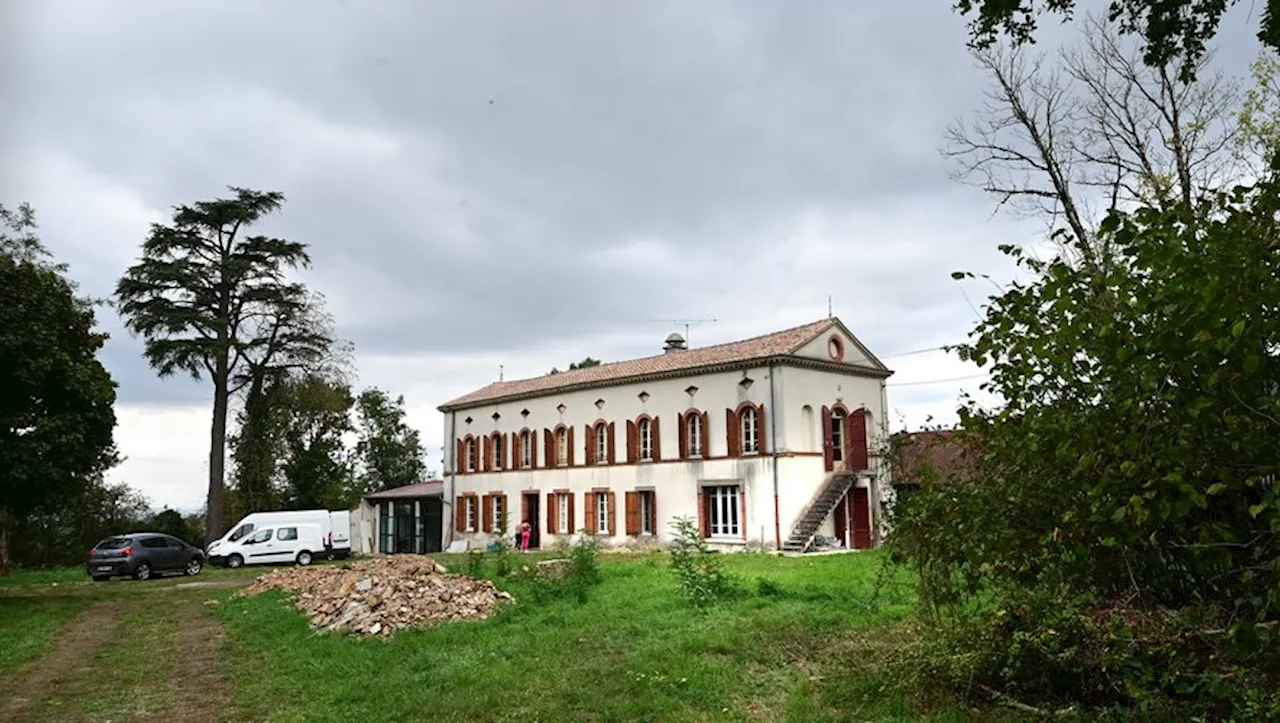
[115,187,330,540]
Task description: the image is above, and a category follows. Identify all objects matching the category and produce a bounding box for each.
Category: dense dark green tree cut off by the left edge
[0,205,116,573]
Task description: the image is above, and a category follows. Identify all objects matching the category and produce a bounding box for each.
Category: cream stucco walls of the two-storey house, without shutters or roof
[444,353,886,549]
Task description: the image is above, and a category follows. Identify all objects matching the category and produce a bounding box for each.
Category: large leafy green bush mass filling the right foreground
[887,182,1280,720]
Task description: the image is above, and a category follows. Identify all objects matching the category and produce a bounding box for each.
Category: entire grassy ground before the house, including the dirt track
[0,553,1015,723]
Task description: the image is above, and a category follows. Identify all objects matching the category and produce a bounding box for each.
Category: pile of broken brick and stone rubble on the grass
[238,555,511,636]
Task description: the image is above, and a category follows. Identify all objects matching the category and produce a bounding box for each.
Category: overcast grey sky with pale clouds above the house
[0,0,1257,509]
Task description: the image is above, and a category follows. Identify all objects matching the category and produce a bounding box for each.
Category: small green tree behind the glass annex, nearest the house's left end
[356,389,426,491]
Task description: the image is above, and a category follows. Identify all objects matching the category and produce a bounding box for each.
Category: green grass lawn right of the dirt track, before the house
[221,554,968,722]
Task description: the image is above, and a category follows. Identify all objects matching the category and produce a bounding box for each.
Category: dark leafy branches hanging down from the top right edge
[952,0,1280,81]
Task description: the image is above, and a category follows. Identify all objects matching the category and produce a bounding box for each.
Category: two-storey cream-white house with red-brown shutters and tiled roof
[439,319,892,550]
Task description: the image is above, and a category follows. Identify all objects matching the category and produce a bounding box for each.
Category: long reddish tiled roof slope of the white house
[439,319,885,411]
